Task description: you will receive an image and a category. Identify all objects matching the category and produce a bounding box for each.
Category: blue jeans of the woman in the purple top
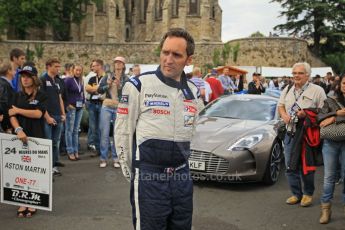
[65,108,83,155]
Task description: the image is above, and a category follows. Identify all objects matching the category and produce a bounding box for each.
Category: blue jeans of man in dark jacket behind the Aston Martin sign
[44,115,62,167]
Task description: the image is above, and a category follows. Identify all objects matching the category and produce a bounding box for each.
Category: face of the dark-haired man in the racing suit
[160,37,192,81]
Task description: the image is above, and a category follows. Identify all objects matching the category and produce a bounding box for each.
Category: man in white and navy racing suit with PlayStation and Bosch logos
[115,28,202,230]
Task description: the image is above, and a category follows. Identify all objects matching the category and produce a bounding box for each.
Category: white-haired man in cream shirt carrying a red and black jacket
[278,63,326,207]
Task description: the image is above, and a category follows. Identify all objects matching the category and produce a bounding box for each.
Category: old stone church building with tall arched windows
[10,0,222,43]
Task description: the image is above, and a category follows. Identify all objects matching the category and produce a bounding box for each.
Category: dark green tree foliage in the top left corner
[0,0,103,41]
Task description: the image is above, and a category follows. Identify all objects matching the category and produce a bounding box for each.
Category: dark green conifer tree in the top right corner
[271,0,345,56]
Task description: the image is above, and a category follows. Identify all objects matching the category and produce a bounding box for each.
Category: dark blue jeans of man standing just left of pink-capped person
[89,103,102,152]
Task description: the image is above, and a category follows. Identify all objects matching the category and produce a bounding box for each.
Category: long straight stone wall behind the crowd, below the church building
[0,41,223,71]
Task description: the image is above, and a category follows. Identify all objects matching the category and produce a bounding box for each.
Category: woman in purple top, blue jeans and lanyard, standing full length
[65,64,85,161]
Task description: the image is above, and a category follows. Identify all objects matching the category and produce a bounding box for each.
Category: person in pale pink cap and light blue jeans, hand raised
[97,56,128,168]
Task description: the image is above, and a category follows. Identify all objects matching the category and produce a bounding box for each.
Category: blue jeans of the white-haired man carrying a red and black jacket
[284,135,315,199]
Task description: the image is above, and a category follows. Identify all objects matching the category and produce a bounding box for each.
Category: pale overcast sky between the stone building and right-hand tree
[219,0,286,42]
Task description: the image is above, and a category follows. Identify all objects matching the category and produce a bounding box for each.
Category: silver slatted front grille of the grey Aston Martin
[189,149,229,173]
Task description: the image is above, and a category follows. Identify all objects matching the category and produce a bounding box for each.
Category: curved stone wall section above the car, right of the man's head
[228,37,325,67]
